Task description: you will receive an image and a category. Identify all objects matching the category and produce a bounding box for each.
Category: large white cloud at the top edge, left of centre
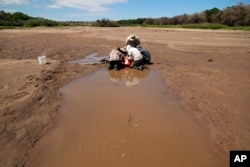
[48,0,127,12]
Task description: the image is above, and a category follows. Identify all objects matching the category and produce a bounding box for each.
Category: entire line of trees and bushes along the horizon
[0,3,250,28]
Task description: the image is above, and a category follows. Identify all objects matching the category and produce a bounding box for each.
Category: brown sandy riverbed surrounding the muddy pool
[0,27,250,166]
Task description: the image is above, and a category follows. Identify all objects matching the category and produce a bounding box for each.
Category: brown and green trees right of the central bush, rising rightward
[117,3,250,26]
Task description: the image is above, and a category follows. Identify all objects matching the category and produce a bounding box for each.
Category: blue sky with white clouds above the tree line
[0,0,250,21]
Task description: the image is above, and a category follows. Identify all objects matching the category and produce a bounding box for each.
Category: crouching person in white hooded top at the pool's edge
[126,45,144,71]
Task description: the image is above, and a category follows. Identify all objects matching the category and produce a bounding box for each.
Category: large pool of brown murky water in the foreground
[29,69,220,167]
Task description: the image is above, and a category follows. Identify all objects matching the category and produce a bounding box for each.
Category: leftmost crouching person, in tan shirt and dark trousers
[108,48,126,70]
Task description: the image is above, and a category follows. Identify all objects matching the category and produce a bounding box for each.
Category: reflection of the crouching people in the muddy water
[108,68,150,86]
